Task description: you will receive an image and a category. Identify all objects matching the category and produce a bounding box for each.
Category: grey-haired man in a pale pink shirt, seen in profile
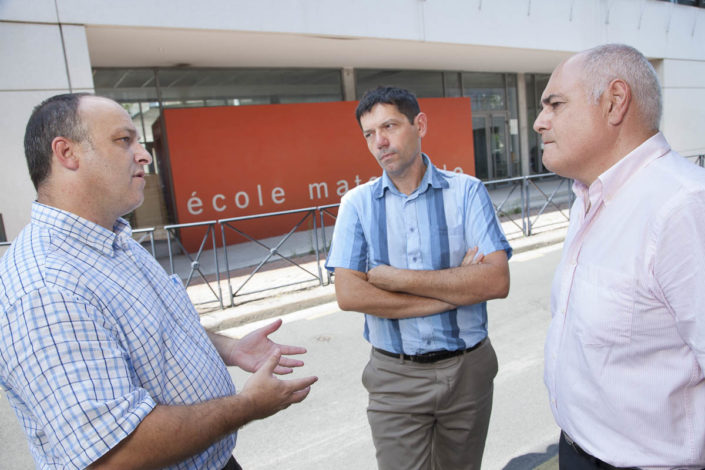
[534,44,705,470]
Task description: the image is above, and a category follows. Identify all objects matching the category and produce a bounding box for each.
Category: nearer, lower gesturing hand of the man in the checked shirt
[239,348,318,419]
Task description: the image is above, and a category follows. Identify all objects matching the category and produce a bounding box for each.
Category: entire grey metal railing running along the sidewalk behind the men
[20,155,692,309]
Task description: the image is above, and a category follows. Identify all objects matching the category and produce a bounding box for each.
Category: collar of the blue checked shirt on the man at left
[32,201,132,256]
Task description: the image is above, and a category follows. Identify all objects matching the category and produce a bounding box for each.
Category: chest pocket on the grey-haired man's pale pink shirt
[568,265,636,346]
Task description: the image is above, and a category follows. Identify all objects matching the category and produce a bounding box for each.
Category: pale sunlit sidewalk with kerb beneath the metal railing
[187,211,568,331]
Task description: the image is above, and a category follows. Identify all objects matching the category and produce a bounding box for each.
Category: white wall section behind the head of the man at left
[0,0,93,240]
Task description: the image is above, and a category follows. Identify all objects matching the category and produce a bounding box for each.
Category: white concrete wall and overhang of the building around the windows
[0,0,705,238]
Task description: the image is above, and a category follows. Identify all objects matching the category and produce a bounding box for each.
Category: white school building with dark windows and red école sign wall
[0,0,705,242]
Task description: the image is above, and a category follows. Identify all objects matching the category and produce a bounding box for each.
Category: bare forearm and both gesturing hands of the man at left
[91,320,318,469]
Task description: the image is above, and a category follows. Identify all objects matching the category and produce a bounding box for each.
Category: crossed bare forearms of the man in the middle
[335,248,509,318]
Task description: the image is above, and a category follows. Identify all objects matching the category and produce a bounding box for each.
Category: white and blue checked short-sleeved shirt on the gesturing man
[0,203,235,469]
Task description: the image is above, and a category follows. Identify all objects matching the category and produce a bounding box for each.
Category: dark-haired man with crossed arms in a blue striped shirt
[326,87,512,470]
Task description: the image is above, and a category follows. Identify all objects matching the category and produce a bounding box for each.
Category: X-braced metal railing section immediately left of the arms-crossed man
[218,207,323,306]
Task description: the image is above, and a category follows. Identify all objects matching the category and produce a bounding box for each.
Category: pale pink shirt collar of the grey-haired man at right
[573,132,671,209]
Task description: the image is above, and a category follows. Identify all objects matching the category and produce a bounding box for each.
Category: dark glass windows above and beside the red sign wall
[93,67,524,180]
